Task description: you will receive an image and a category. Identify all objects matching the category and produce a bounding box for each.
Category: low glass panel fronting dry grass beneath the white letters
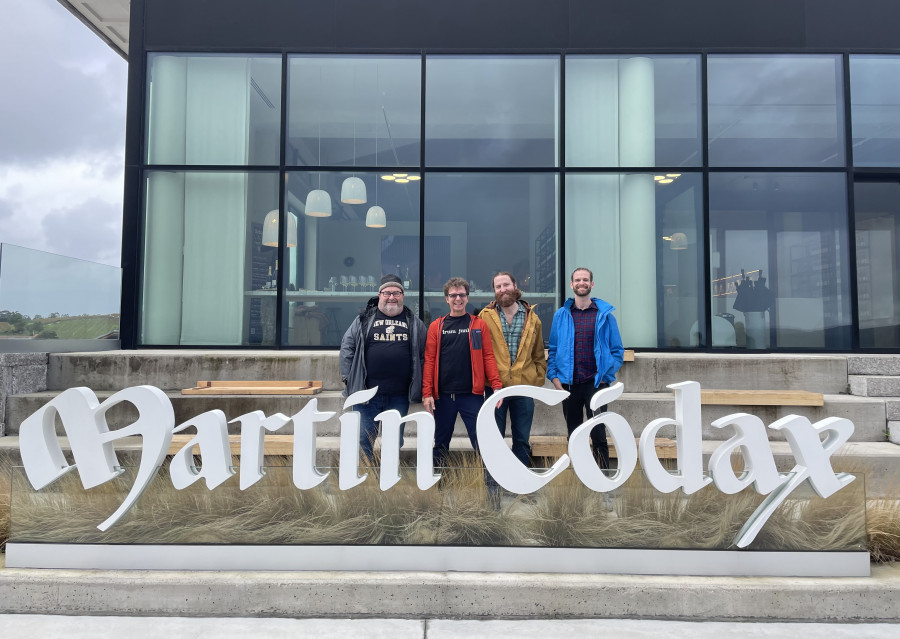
[9,458,867,552]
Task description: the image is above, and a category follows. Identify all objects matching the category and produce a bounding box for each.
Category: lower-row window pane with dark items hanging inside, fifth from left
[709,173,851,350]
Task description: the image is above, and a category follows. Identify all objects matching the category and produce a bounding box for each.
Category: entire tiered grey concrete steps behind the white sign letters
[0,350,900,492]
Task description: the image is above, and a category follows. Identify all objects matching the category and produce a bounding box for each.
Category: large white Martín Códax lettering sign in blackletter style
[19,382,854,548]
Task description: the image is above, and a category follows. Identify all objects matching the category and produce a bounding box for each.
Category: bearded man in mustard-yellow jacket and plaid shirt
[478,271,547,467]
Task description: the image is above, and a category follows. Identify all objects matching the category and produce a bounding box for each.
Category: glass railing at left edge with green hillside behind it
[0,244,122,353]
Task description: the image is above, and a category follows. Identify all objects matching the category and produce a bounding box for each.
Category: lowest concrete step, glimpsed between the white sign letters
[0,436,900,499]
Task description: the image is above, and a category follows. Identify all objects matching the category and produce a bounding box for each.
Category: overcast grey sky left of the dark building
[0,0,127,266]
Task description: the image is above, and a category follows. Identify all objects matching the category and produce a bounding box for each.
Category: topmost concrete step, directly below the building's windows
[46,350,852,395]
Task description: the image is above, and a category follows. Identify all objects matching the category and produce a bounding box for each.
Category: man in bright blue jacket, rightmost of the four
[547,267,625,469]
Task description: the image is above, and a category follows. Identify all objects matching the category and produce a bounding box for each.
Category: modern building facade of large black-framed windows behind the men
[95,0,900,352]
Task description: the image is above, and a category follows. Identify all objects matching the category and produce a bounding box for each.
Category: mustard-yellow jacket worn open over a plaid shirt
[478,300,547,388]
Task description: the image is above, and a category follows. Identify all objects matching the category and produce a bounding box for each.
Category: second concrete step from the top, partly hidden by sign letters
[6,391,886,442]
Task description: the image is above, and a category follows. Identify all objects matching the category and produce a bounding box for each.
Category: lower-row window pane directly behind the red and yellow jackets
[424,173,558,330]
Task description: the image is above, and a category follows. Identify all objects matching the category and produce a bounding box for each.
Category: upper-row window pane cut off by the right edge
[850,55,900,166]
